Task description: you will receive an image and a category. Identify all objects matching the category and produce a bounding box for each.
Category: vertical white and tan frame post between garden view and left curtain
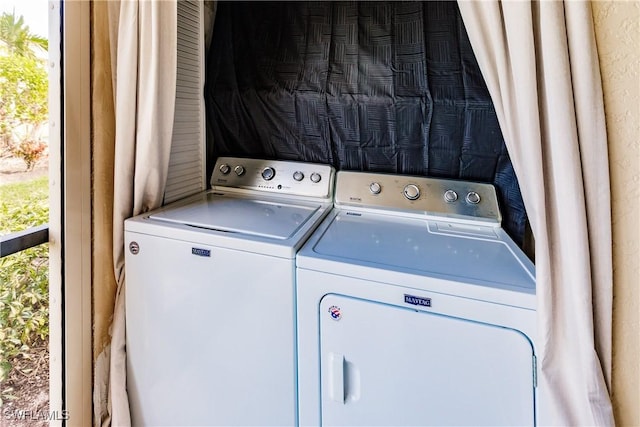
[49,0,93,427]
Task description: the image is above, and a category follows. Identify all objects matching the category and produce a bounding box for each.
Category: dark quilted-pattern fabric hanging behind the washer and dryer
[205,1,526,243]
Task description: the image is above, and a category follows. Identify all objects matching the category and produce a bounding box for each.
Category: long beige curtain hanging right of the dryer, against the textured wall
[458,0,613,426]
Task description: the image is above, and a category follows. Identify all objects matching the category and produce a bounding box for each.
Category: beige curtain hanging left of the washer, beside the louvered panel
[93,0,177,426]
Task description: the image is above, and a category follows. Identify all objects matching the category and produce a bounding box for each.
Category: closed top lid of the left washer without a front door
[150,193,321,240]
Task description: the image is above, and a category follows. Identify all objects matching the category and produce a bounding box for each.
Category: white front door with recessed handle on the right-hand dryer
[319,294,535,426]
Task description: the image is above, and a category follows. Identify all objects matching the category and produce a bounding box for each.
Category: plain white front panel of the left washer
[126,232,296,426]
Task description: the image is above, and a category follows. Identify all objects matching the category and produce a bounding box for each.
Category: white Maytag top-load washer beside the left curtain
[125,157,334,426]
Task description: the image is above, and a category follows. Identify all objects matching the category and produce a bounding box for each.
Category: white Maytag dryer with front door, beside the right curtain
[297,172,537,426]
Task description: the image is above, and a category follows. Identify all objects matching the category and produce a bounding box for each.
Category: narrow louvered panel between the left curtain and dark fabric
[164,0,206,204]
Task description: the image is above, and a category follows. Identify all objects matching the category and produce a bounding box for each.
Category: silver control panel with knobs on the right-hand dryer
[335,171,502,223]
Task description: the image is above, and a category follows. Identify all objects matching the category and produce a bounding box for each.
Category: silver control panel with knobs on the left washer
[211,157,335,199]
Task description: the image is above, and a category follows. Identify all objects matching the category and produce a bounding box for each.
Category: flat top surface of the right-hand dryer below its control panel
[313,211,535,289]
